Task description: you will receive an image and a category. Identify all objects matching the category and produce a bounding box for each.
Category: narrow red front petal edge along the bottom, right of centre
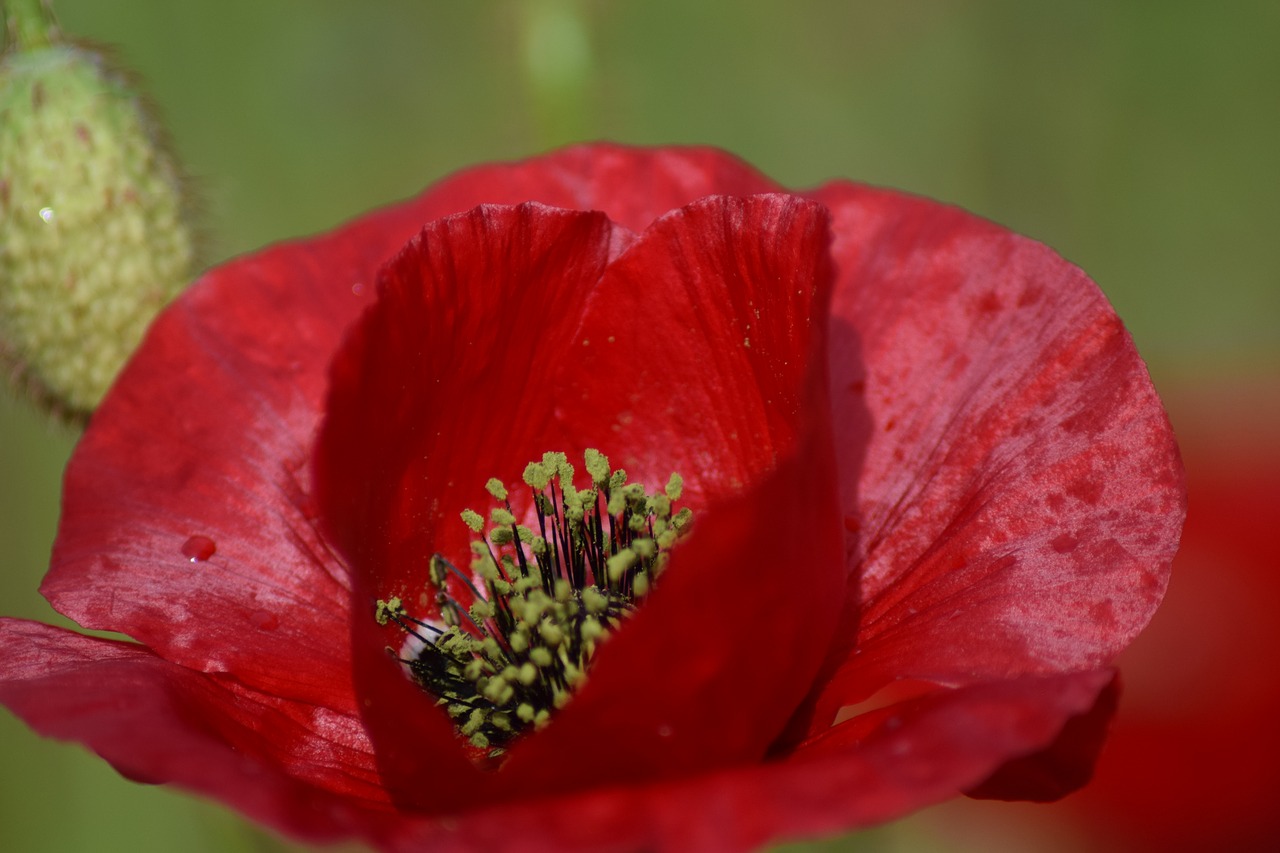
[373,671,1114,852]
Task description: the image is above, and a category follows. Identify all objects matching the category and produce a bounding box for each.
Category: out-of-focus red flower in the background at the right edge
[1068,381,1280,853]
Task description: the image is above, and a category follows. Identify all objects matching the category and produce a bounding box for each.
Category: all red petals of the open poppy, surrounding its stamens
[0,146,1183,849]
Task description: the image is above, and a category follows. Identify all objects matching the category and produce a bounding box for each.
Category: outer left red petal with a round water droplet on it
[41,178,494,711]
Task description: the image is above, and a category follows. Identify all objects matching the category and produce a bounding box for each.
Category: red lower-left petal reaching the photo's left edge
[0,619,389,840]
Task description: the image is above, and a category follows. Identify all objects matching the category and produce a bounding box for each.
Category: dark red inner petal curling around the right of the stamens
[509,196,844,784]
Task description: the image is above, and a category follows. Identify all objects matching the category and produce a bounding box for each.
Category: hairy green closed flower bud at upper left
[0,15,196,418]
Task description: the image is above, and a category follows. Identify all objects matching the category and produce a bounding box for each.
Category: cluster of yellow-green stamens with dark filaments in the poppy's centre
[376,450,692,758]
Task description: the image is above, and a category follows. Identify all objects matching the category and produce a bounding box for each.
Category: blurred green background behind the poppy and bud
[0,0,1280,850]
